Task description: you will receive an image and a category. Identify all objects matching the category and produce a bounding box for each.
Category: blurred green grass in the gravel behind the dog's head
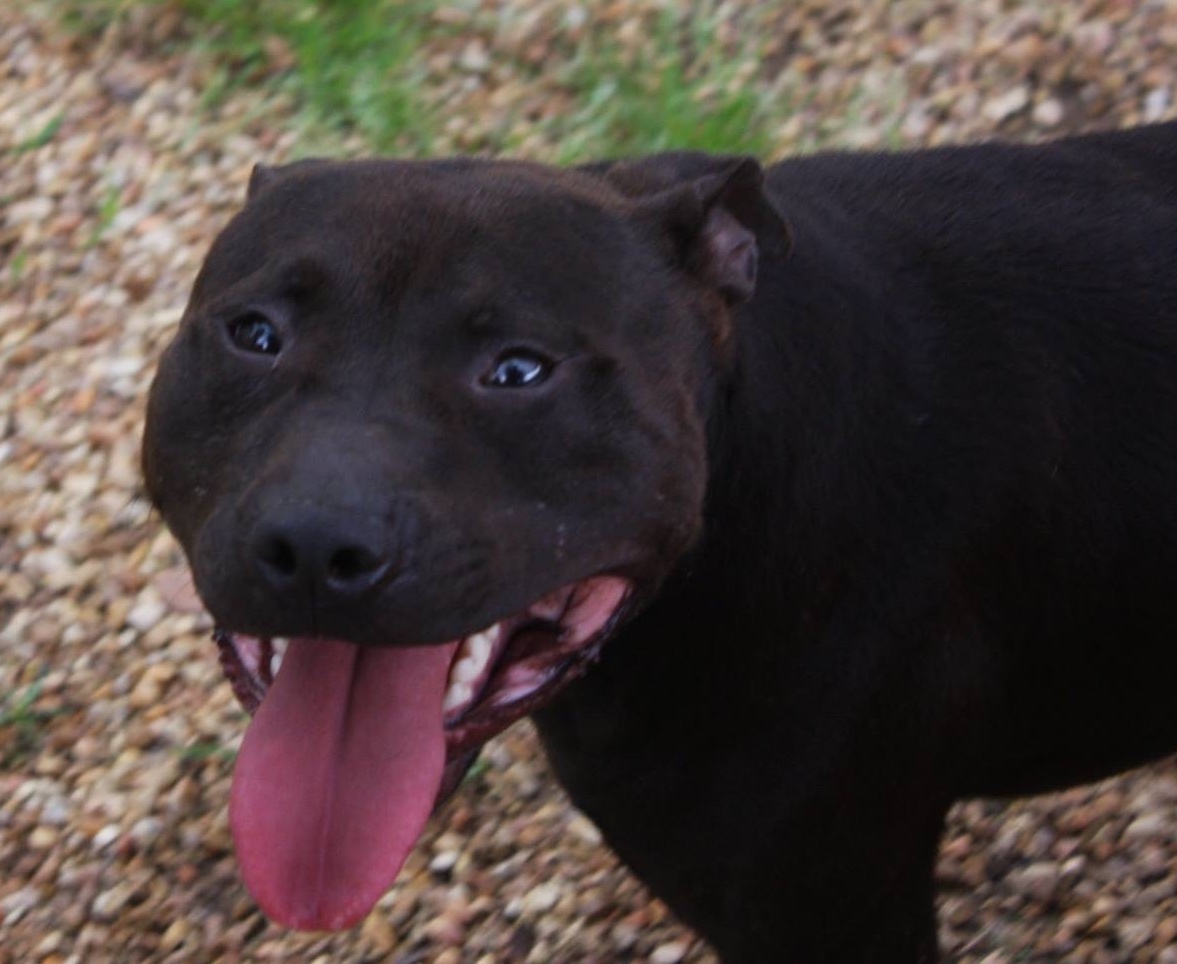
[54,0,783,161]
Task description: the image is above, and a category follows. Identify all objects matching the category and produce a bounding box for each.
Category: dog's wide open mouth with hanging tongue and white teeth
[215,576,631,930]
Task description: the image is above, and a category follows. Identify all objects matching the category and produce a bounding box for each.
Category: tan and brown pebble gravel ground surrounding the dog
[0,0,1177,964]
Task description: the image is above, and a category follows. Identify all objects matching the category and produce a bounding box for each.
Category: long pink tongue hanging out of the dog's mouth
[230,639,457,930]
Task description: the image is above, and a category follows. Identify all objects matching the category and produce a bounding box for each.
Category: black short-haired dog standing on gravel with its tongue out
[142,124,1177,964]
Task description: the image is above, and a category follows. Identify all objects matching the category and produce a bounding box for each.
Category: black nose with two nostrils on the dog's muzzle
[252,514,392,601]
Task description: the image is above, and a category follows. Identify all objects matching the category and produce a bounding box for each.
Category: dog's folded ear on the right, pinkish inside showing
[586,153,792,304]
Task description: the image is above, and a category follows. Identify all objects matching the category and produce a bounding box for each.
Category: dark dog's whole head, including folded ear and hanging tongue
[144,157,783,928]
